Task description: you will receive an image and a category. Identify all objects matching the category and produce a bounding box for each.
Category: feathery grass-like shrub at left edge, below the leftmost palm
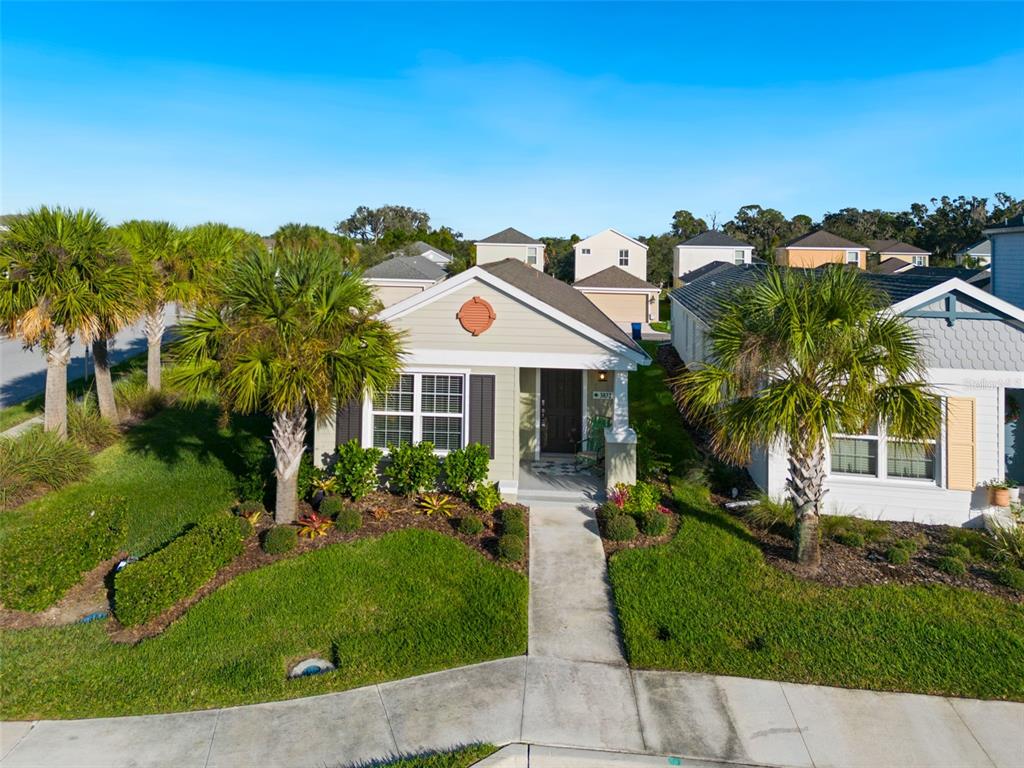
[0,428,92,509]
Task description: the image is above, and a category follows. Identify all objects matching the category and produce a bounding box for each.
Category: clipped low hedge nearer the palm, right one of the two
[114,516,243,627]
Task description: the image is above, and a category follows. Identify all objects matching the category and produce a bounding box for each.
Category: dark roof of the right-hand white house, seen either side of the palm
[669,262,958,325]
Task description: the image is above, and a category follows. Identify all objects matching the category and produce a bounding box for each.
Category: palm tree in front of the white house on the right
[674,268,939,567]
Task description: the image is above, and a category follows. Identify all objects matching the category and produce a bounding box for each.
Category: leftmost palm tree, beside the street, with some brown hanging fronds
[0,206,134,436]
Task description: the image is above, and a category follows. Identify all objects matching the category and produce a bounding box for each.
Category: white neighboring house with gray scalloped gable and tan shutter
[670,264,1024,525]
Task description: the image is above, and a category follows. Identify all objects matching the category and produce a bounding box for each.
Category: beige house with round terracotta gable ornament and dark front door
[313,258,650,500]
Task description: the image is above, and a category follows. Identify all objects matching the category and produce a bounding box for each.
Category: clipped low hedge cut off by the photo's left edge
[0,497,127,610]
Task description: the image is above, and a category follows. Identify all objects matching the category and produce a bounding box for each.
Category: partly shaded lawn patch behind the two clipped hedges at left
[0,406,267,555]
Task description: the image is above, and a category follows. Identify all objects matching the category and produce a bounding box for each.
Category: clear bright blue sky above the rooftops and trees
[0,2,1024,237]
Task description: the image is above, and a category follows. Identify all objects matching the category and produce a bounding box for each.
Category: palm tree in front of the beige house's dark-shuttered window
[167,247,401,522]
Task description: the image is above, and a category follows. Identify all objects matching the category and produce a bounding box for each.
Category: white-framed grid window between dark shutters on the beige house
[373,374,465,451]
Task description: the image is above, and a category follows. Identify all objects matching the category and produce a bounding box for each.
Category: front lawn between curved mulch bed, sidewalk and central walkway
[0,529,527,720]
